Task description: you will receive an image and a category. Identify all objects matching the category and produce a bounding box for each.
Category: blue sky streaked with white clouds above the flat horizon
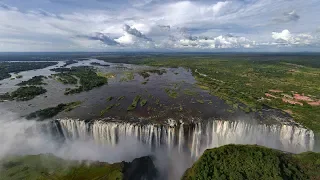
[0,0,320,52]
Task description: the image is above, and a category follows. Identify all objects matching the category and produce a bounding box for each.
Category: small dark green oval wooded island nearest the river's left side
[7,86,47,101]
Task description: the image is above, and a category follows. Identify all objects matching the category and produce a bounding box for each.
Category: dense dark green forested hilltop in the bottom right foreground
[182,145,320,180]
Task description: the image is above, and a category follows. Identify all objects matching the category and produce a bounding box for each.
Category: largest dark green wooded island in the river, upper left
[53,66,108,95]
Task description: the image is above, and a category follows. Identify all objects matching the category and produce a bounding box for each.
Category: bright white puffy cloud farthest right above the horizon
[272,29,315,45]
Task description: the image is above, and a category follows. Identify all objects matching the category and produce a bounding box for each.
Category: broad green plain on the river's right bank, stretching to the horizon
[139,55,320,132]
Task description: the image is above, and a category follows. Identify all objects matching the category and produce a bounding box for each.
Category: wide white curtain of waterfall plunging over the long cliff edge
[57,119,314,157]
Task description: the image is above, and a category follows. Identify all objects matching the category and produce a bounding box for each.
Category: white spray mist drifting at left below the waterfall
[0,110,151,163]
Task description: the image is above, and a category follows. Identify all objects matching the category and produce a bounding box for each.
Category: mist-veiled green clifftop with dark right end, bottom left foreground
[0,154,157,180]
